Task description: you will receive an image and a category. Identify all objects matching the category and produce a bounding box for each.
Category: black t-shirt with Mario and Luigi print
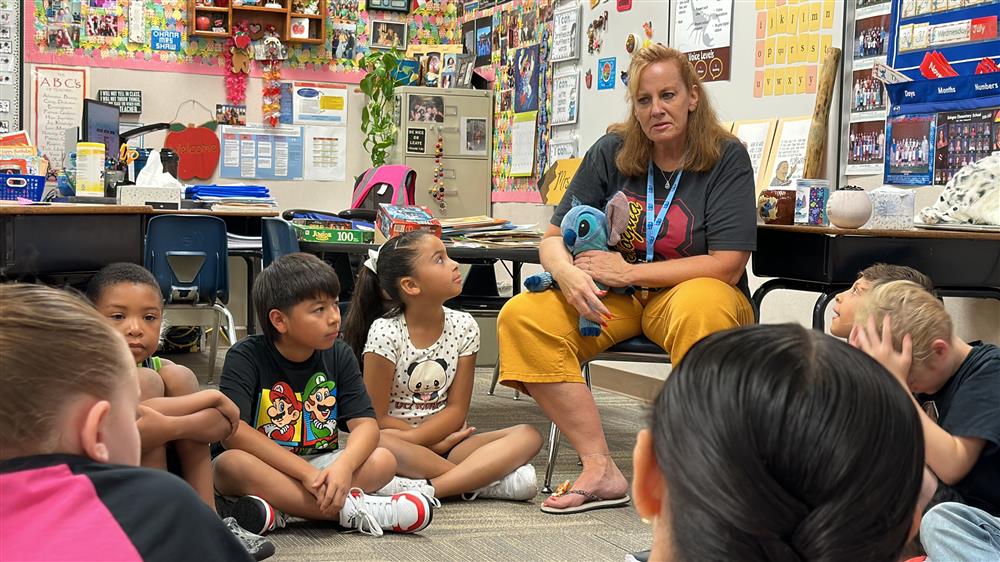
[219,335,375,455]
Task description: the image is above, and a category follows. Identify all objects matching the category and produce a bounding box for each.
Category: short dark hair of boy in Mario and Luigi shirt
[253,252,340,342]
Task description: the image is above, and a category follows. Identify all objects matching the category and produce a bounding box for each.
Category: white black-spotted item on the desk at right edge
[920,152,1000,226]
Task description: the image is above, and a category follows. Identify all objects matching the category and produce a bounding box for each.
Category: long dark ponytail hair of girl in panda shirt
[344,230,433,363]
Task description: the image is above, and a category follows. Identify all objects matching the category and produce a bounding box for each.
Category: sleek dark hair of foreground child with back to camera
[651,324,924,562]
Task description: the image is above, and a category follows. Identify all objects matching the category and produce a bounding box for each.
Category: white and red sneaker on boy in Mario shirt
[340,488,434,537]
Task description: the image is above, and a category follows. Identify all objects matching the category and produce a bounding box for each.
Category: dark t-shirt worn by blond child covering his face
[917,342,1000,516]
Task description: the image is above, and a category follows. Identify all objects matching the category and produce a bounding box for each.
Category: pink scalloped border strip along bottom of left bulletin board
[21,10,364,84]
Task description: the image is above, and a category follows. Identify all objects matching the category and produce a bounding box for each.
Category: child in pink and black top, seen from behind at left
[0,284,251,562]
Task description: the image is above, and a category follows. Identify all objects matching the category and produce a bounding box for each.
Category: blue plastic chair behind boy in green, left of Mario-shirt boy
[144,215,236,383]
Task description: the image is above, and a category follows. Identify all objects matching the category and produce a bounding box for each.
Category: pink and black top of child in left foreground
[0,454,253,562]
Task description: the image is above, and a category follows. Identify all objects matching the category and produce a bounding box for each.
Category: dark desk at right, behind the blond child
[752,225,1000,330]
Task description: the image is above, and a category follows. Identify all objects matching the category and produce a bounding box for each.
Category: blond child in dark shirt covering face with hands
[851,281,1000,516]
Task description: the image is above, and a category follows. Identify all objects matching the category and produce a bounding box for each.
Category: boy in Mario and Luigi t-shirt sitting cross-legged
[215,253,431,536]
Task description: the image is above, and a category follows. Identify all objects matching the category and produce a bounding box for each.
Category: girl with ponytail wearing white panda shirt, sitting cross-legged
[345,232,542,500]
